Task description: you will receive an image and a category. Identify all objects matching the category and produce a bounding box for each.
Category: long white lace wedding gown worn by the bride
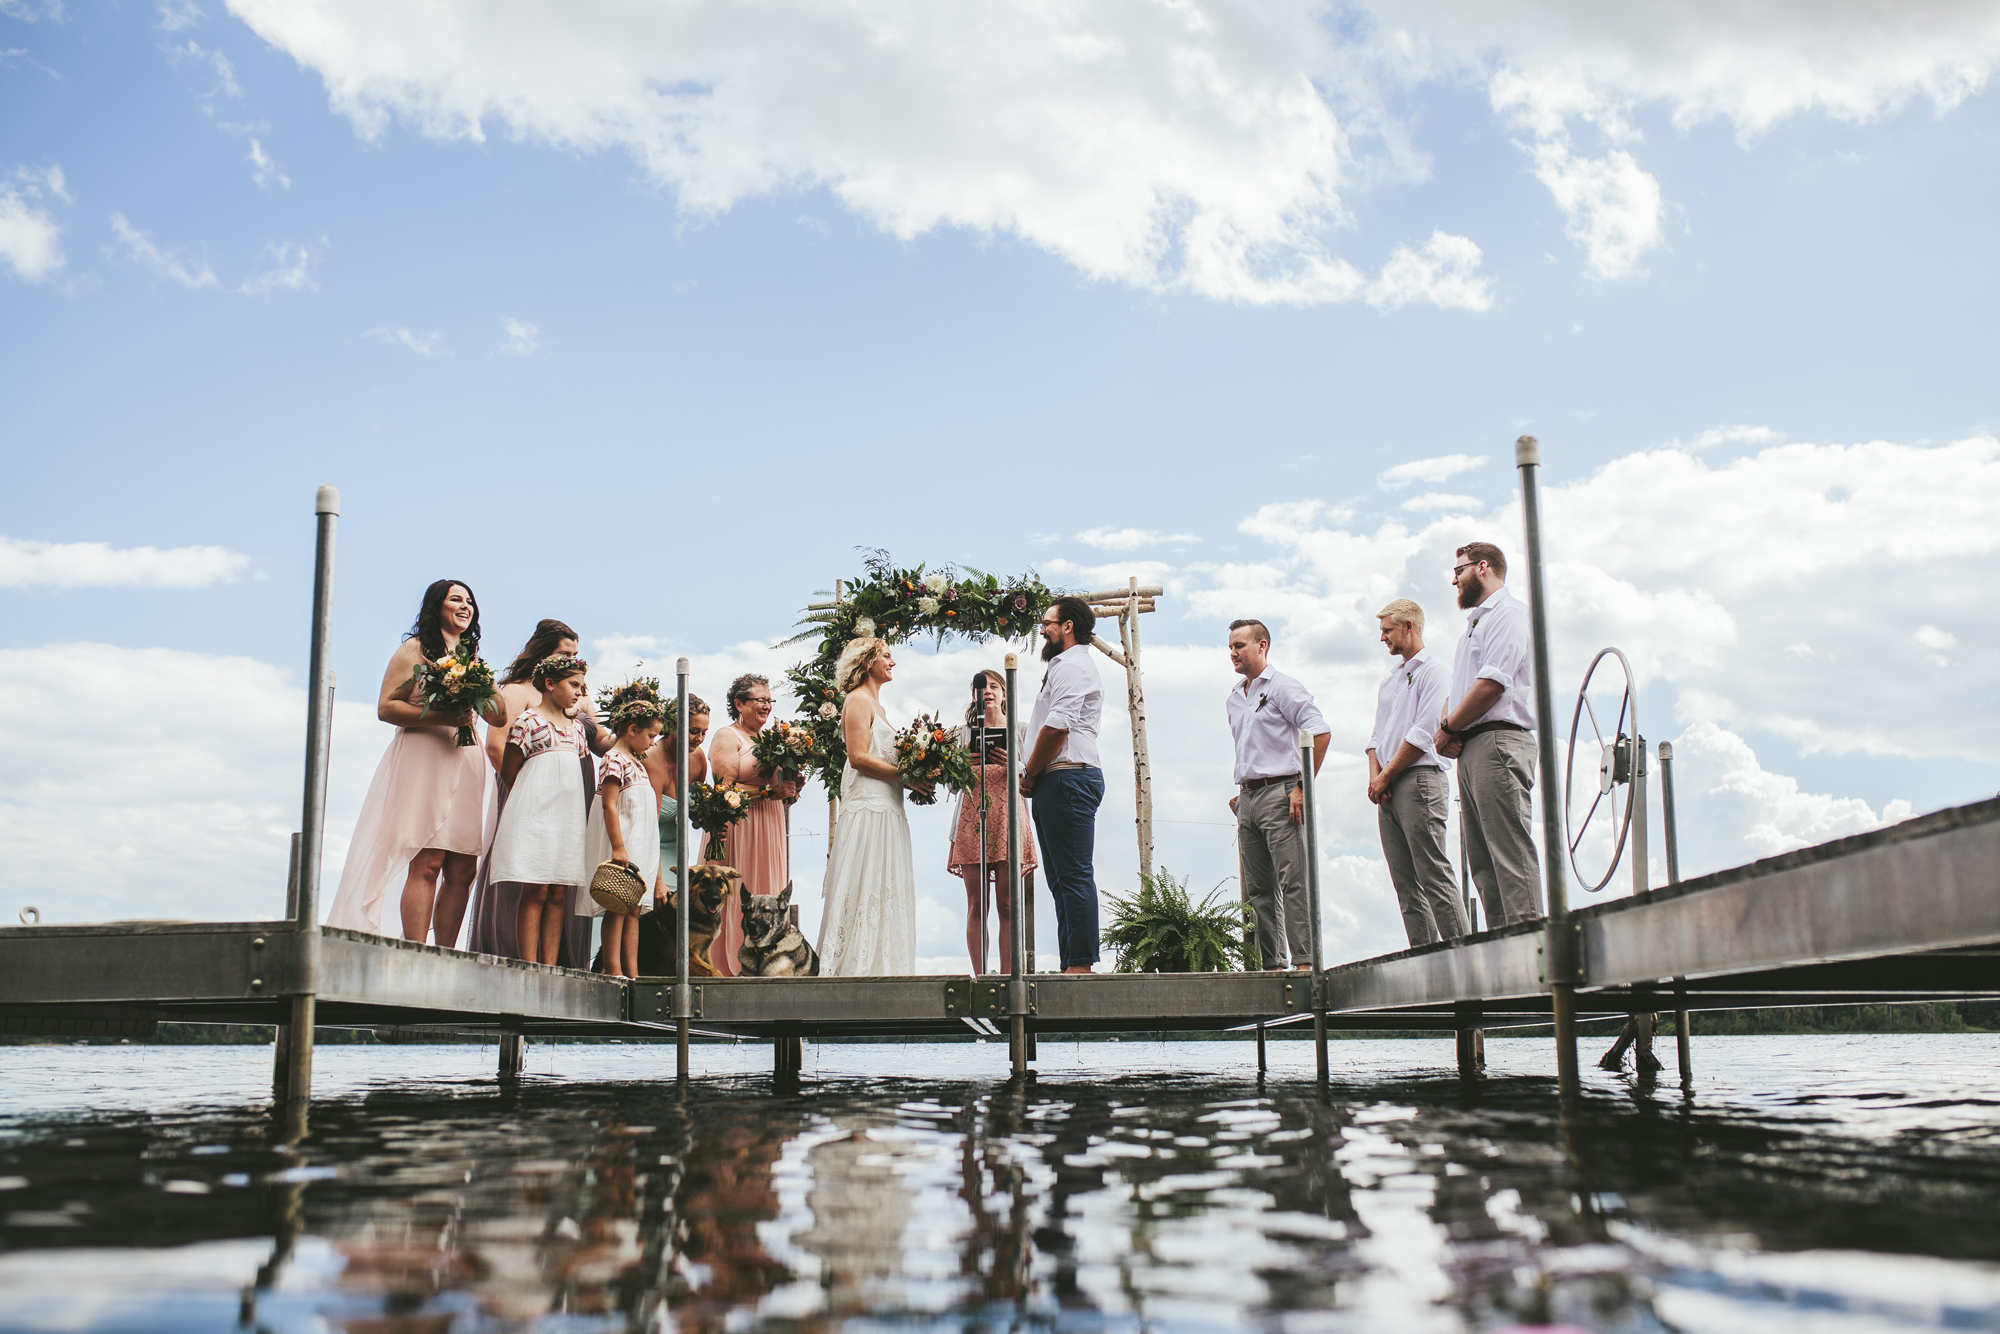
[820,714,916,978]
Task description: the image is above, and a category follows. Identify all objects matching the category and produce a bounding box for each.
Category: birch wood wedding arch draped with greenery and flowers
[786,550,1164,876]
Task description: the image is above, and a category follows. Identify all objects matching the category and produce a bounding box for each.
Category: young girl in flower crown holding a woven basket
[576,680,666,978]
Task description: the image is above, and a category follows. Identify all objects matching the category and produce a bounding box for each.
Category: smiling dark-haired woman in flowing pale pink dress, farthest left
[326,580,504,948]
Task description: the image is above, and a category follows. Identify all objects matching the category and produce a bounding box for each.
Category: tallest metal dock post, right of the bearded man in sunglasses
[1514,436,1582,1098]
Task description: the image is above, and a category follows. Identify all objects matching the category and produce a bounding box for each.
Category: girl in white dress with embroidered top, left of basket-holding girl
[492,654,590,964]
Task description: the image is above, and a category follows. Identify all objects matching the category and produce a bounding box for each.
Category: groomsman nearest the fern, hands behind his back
[1224,620,1332,970]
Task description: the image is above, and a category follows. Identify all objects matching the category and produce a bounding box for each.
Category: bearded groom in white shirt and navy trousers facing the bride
[1020,598,1104,972]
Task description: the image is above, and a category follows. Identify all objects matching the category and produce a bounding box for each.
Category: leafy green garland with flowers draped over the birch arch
[784,548,1062,798]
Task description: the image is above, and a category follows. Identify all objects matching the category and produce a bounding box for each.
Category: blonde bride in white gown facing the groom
[820,638,916,978]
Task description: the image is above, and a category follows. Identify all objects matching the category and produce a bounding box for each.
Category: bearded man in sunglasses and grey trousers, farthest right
[1434,542,1542,926]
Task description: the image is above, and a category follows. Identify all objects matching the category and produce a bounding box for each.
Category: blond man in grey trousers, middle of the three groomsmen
[1368,598,1466,944]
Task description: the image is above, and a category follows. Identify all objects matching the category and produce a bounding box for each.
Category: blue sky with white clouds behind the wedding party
[0,0,2000,970]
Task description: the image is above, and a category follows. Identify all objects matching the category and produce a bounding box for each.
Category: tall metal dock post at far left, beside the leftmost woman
[272,486,340,1134]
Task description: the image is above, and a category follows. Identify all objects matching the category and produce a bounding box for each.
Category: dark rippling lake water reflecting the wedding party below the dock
[0,1034,2000,1334]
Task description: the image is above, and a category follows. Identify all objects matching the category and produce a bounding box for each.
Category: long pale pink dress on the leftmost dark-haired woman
[326,682,492,948]
